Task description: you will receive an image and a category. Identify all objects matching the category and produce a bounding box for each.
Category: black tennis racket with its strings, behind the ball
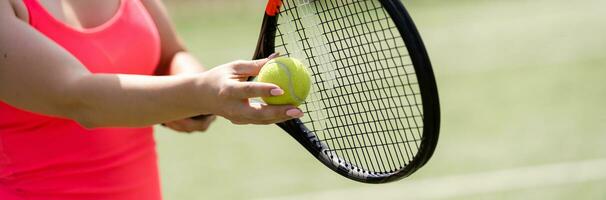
[254,0,440,183]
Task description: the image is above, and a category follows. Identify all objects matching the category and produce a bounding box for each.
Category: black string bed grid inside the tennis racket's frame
[276,0,423,172]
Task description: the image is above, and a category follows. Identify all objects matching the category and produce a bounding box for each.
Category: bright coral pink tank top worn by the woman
[0,0,161,200]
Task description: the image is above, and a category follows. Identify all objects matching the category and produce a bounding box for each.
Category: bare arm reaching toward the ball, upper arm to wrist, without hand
[0,14,211,127]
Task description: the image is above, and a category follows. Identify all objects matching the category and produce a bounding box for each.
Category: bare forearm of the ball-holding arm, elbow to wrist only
[68,74,208,127]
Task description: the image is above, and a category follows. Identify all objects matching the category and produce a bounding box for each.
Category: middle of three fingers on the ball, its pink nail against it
[232,82,284,99]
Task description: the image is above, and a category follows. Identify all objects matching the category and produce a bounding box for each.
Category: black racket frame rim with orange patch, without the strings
[250,0,440,183]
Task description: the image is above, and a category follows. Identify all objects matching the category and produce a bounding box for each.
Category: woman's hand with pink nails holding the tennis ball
[199,54,303,124]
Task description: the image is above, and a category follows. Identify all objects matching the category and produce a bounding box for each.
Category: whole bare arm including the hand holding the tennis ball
[0,0,292,127]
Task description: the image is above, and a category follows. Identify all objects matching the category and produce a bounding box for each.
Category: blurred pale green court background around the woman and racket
[156,0,606,200]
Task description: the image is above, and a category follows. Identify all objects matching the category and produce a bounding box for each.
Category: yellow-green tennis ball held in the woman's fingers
[257,57,311,106]
